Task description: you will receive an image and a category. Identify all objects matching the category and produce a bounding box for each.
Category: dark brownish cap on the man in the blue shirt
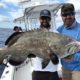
[61,3,75,15]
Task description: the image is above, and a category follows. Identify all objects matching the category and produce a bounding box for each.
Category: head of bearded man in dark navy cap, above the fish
[39,9,51,30]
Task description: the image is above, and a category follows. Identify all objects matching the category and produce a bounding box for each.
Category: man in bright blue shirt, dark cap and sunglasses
[57,3,80,80]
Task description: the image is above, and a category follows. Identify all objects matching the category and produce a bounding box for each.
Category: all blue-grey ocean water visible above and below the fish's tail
[0,28,13,77]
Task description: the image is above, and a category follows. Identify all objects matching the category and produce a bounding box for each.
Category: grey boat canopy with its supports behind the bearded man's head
[14,3,63,30]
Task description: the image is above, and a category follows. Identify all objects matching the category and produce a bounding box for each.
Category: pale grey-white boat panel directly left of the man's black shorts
[14,58,32,80]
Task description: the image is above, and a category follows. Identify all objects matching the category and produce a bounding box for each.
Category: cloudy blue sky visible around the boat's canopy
[0,0,80,28]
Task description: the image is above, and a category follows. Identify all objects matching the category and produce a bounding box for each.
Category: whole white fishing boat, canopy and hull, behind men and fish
[0,3,63,80]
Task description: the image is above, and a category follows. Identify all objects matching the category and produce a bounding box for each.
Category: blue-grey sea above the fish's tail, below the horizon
[0,28,13,48]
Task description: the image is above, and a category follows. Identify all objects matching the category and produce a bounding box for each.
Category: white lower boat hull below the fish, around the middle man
[0,59,62,80]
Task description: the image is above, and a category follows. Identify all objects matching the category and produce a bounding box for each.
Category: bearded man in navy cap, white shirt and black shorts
[32,9,59,80]
